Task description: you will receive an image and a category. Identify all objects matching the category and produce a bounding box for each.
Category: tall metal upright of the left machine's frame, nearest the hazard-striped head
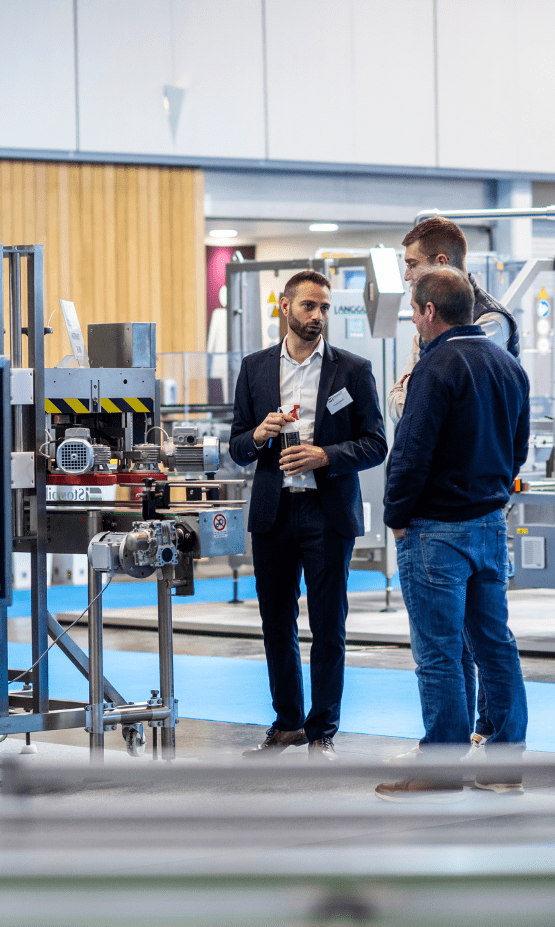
[25,245,49,712]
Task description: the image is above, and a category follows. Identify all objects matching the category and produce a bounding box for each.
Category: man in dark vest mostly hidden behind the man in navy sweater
[387,216,520,760]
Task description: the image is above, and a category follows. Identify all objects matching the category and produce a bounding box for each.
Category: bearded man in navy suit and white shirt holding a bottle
[229,270,387,760]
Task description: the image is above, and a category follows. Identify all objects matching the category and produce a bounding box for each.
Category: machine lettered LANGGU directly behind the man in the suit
[226,247,404,608]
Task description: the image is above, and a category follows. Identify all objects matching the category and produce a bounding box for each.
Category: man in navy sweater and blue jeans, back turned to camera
[376,266,530,799]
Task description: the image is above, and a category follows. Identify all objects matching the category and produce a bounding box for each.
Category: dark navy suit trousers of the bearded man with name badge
[252,489,354,741]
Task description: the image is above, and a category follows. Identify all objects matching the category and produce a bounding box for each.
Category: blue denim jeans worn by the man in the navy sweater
[397,511,528,750]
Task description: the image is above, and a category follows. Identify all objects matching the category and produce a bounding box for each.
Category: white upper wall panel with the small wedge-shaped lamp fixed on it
[79,0,264,158]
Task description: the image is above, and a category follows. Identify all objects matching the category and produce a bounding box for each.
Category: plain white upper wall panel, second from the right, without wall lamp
[266,0,435,166]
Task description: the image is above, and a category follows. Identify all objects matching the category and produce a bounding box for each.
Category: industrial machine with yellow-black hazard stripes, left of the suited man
[0,245,244,759]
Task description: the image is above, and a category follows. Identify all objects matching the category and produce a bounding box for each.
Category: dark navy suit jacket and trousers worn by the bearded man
[229,342,387,740]
